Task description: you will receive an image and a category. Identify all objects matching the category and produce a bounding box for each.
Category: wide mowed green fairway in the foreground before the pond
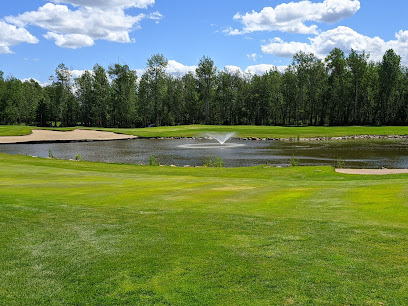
[0,154,408,305]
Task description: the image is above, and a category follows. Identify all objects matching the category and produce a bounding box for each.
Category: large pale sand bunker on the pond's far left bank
[0,130,137,144]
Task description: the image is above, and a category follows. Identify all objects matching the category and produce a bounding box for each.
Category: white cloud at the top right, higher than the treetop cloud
[224,0,360,35]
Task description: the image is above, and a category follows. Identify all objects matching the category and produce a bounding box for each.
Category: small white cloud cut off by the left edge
[0,20,38,54]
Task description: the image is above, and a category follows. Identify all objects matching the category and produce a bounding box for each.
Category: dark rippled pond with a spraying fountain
[0,139,408,168]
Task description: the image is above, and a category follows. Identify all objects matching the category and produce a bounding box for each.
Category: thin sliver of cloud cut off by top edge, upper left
[52,0,155,9]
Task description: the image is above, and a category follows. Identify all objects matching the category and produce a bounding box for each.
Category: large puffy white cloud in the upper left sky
[5,0,163,49]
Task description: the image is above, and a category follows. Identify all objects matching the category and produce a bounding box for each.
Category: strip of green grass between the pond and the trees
[0,125,408,139]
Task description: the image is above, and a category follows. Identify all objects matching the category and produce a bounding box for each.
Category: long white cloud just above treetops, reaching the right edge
[262,26,408,64]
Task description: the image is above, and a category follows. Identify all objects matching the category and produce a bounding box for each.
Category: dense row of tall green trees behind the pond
[0,48,408,127]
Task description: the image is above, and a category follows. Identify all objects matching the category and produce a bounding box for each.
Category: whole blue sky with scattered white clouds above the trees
[0,0,408,83]
